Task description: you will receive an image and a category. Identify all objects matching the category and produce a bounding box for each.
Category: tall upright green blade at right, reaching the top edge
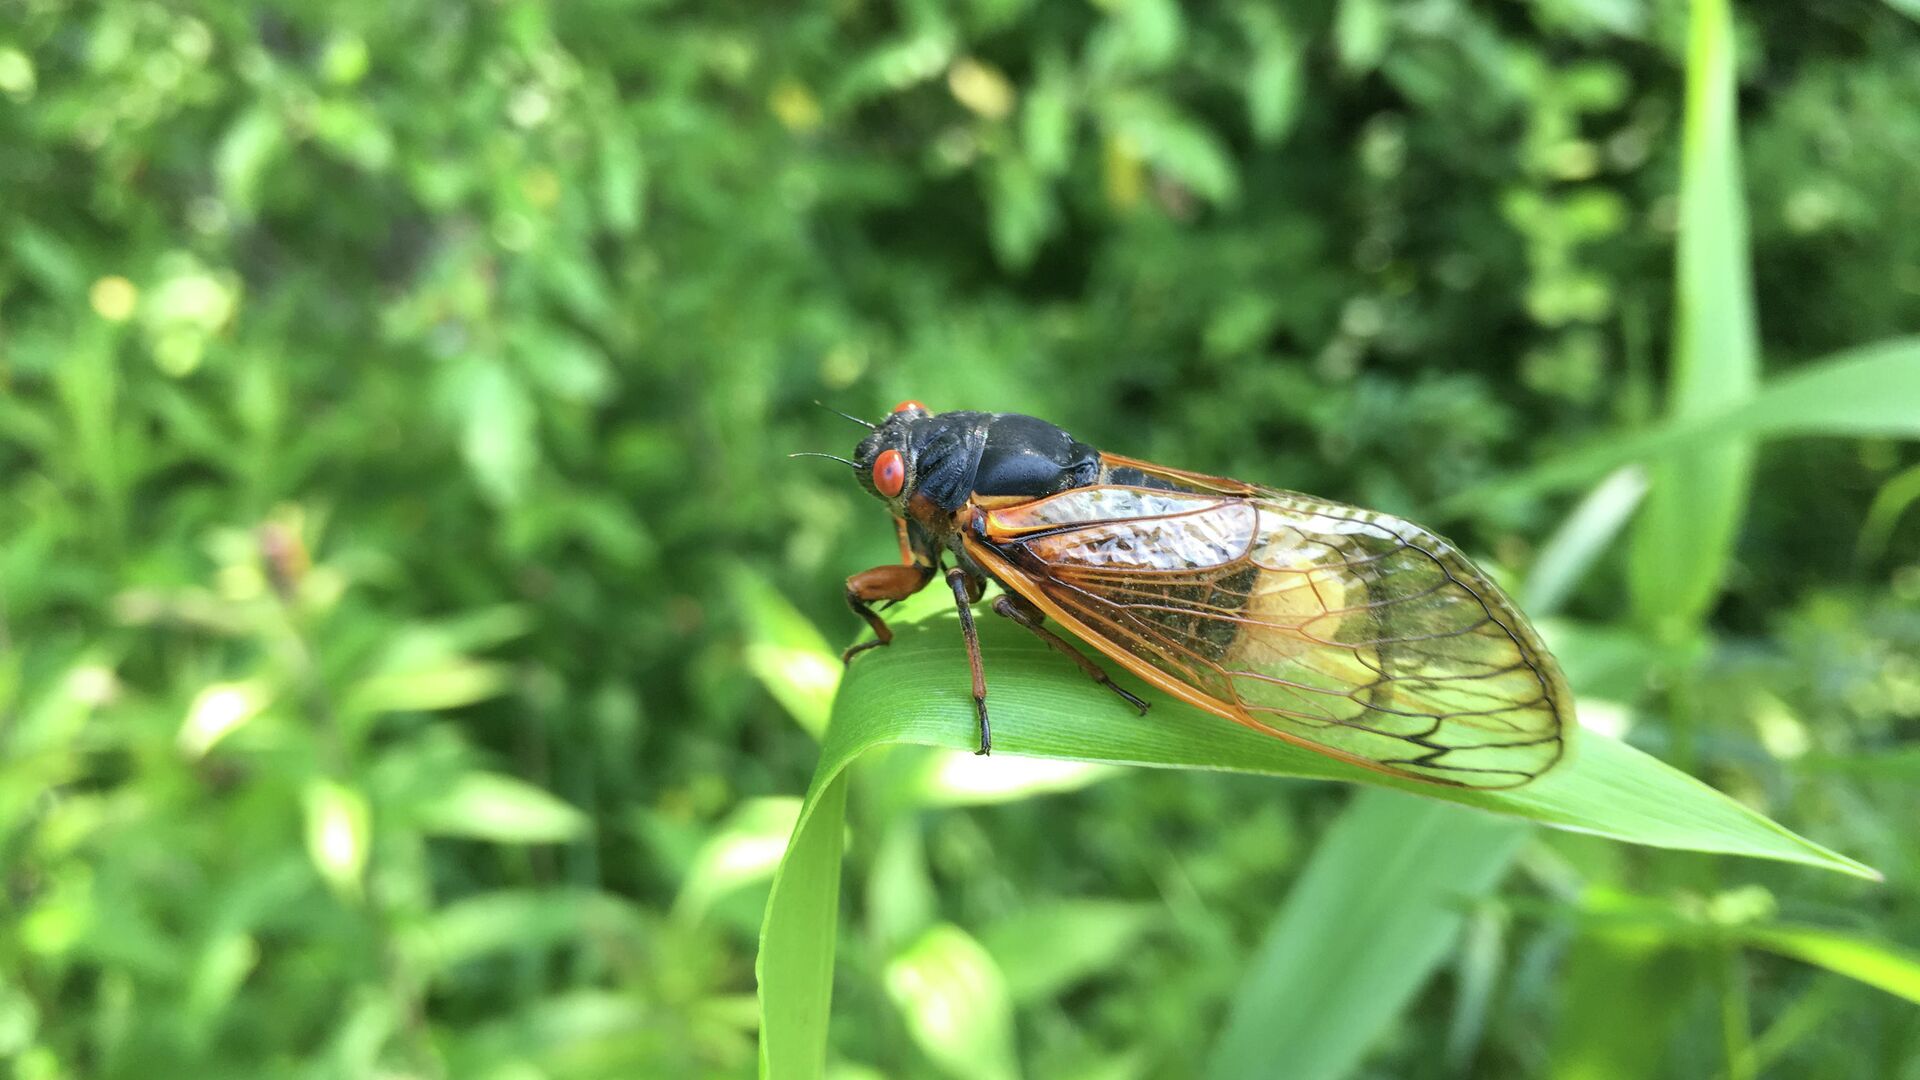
[1628,0,1761,628]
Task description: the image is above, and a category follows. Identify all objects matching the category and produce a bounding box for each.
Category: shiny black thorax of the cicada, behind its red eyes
[894,411,1100,509]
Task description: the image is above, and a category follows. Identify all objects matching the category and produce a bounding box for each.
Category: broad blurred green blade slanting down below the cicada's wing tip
[1206,792,1526,1080]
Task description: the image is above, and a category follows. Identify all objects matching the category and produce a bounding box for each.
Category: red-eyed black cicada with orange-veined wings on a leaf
[810,402,1572,788]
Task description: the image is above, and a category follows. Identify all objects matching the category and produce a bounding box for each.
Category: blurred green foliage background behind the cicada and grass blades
[0,0,1920,1080]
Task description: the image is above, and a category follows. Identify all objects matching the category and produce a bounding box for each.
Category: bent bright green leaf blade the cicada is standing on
[756,594,1878,1078]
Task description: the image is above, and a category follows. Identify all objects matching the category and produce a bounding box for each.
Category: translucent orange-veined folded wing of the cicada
[968,459,1572,788]
